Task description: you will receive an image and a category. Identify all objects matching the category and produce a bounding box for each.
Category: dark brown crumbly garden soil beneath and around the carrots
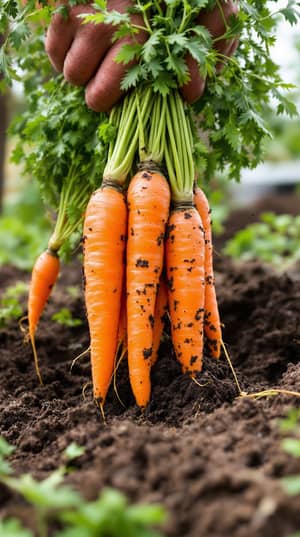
[0,193,300,537]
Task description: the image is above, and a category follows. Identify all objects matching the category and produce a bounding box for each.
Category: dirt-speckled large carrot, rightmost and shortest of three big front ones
[166,203,205,376]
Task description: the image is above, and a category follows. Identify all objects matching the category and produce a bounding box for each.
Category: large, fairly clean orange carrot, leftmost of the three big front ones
[83,182,127,408]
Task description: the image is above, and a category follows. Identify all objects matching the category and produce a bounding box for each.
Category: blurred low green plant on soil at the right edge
[224,212,300,271]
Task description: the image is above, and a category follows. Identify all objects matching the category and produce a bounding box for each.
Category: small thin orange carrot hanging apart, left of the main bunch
[28,248,59,384]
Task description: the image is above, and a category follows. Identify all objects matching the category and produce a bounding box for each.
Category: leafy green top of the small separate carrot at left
[10,77,107,258]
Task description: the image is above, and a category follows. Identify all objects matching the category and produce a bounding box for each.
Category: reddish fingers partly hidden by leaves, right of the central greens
[181,0,238,104]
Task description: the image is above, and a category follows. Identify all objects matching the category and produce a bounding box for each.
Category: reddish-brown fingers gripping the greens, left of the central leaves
[46,0,147,112]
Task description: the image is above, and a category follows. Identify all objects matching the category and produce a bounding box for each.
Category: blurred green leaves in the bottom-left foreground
[0,437,166,537]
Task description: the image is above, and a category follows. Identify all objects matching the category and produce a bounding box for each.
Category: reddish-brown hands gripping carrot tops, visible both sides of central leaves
[46,0,237,112]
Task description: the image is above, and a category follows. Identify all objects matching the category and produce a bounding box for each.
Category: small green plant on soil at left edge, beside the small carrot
[0,282,28,326]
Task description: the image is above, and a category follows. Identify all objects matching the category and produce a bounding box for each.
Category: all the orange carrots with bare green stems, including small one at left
[28,86,222,411]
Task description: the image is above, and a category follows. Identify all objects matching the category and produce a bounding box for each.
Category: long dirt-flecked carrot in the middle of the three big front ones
[127,165,170,408]
